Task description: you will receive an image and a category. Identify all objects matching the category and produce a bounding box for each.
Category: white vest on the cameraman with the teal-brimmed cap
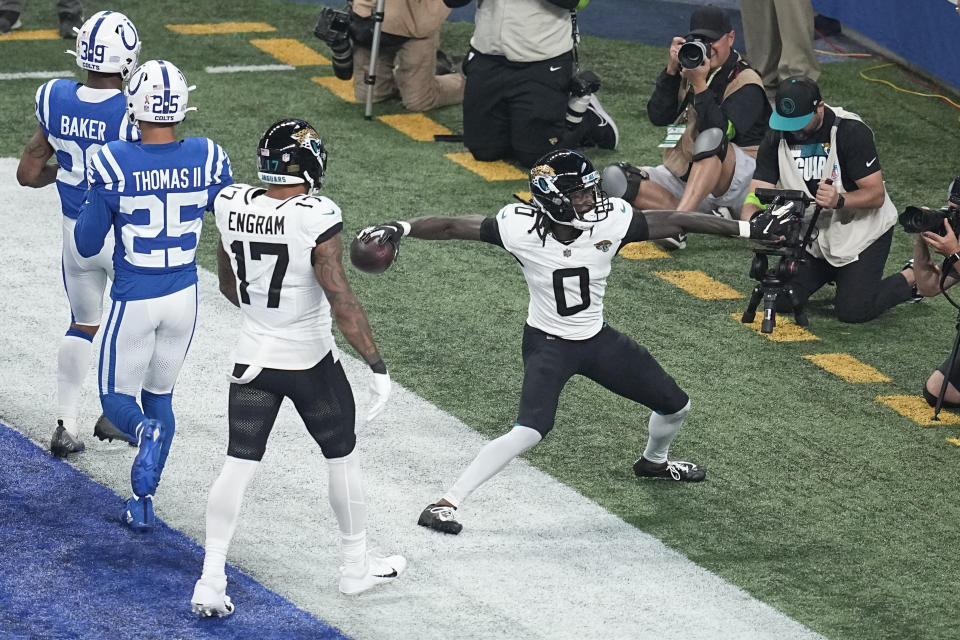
[777,107,897,267]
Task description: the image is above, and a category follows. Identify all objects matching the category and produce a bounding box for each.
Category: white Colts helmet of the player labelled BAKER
[67,11,141,80]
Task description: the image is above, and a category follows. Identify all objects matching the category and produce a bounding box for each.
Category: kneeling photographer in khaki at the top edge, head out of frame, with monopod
[314,0,466,111]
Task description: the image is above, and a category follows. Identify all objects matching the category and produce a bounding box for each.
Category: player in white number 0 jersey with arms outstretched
[358,149,779,534]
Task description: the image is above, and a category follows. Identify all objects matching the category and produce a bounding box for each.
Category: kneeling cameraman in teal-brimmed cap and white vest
[741,76,920,322]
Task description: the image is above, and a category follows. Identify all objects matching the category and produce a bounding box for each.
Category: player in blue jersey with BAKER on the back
[17,11,140,457]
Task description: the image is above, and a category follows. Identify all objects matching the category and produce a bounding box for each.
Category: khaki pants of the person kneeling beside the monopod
[353,32,466,111]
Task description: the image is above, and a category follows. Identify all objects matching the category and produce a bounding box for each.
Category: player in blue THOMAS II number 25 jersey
[74,60,233,531]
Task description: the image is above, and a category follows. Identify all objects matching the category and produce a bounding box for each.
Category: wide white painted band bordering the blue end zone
[0,156,822,640]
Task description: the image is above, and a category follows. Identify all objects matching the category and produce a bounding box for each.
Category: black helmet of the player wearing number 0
[530,149,613,231]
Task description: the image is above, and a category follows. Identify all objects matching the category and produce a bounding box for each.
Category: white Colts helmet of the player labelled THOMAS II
[123,60,197,124]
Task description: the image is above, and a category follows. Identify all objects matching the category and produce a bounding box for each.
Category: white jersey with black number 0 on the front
[496,198,642,340]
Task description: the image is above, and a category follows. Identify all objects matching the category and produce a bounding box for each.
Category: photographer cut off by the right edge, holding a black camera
[900,176,960,409]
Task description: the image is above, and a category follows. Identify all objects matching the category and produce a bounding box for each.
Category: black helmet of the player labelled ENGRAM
[257,119,327,191]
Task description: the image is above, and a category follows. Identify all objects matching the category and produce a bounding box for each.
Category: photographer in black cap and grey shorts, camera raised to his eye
[604,6,770,248]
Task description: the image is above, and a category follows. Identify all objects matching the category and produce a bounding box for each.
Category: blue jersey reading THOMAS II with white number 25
[74,138,233,300]
